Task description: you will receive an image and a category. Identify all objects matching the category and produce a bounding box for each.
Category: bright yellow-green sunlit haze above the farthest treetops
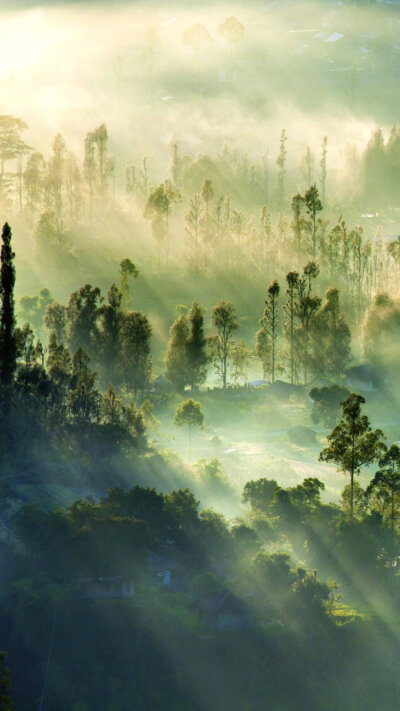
[0,2,396,184]
